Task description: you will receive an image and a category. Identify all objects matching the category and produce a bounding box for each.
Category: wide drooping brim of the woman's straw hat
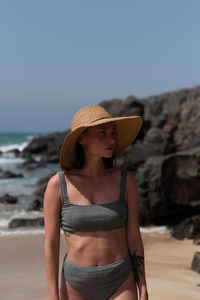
[60,116,143,170]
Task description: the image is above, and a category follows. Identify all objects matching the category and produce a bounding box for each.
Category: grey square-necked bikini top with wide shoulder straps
[58,168,127,233]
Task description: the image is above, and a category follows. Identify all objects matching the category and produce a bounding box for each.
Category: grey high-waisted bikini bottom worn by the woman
[62,254,132,300]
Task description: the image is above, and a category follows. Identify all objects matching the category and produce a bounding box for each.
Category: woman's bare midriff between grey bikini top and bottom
[65,227,128,266]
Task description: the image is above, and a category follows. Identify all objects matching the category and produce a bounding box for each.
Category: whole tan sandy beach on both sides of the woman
[0,231,200,300]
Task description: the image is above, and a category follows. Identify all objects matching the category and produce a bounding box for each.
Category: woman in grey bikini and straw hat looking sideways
[44,105,148,300]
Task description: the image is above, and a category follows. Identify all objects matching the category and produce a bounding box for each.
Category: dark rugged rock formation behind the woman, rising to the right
[23,86,200,226]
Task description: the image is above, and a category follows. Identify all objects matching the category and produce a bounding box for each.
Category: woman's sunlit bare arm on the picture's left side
[43,174,61,300]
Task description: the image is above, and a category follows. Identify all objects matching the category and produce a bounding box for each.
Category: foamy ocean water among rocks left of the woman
[0,132,58,236]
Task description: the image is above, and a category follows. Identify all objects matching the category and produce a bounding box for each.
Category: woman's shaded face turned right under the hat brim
[79,122,116,158]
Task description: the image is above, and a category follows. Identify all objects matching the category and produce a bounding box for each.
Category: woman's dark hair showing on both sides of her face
[72,142,114,170]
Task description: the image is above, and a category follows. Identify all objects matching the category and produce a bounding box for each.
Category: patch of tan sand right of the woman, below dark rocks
[143,234,200,300]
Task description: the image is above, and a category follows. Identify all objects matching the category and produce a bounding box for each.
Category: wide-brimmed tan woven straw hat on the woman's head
[60,105,143,170]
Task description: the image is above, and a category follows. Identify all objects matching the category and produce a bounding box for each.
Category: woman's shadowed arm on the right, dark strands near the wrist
[126,172,148,300]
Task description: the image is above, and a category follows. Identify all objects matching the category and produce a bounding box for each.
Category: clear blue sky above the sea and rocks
[0,0,200,132]
